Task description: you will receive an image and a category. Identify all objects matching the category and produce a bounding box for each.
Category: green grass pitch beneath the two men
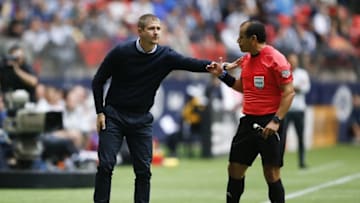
[0,145,360,203]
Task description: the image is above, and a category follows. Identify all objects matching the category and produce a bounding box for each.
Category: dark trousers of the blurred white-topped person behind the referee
[284,111,305,167]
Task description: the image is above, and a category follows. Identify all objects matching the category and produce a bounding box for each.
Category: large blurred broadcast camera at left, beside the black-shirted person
[4,90,63,163]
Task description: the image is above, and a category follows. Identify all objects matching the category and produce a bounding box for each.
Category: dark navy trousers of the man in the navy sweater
[94,106,153,203]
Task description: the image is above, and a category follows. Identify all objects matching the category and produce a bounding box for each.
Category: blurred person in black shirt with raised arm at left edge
[0,45,38,101]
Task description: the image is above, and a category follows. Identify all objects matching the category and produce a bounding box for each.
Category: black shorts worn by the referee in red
[229,114,285,167]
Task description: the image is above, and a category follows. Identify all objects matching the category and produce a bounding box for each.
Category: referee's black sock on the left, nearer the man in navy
[226,177,245,203]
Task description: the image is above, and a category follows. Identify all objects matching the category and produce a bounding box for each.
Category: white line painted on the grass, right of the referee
[263,173,360,203]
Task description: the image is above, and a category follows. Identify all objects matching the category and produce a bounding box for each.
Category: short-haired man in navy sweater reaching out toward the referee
[92,14,211,203]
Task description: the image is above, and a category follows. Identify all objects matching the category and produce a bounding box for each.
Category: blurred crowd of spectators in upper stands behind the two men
[0,0,360,80]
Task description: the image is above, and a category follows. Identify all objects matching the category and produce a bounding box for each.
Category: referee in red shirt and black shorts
[207,21,295,203]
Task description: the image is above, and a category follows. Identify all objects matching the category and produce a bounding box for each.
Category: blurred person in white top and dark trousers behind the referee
[284,53,311,168]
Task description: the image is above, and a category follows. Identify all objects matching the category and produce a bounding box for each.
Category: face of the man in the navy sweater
[138,20,161,46]
